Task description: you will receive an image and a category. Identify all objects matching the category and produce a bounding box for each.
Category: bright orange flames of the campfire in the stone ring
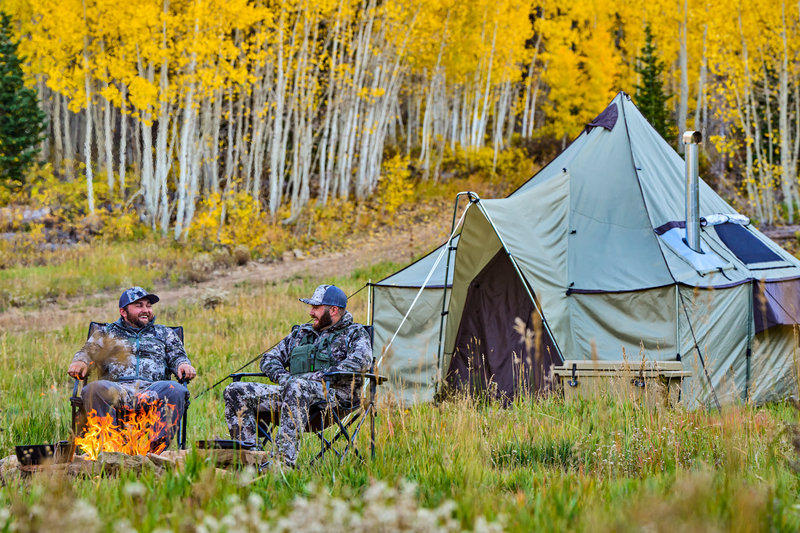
[75,399,177,461]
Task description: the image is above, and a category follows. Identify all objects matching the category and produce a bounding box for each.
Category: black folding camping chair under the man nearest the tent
[230,326,387,464]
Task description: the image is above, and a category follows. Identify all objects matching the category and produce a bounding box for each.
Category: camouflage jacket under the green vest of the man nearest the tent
[260,311,372,389]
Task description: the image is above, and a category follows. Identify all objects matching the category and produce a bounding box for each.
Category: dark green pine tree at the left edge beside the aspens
[0,12,45,187]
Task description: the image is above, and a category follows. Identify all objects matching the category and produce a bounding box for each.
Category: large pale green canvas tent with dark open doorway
[373,93,800,405]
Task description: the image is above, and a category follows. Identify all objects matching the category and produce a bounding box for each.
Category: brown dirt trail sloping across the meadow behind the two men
[0,221,449,332]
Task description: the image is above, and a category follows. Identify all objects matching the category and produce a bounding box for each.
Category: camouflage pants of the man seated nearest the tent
[223,377,349,466]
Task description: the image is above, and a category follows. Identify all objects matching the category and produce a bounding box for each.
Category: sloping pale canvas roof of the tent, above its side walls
[378,93,800,292]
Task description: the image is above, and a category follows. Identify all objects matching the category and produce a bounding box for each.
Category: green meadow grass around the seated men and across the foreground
[0,263,800,533]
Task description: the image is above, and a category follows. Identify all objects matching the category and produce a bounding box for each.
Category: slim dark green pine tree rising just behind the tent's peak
[635,24,676,142]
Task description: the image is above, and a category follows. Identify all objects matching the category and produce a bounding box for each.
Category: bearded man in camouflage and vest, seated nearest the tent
[224,285,372,468]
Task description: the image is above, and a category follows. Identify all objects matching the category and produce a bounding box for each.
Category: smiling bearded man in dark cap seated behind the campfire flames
[67,287,197,449]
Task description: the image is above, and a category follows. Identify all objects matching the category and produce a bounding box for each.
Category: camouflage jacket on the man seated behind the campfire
[72,317,191,381]
